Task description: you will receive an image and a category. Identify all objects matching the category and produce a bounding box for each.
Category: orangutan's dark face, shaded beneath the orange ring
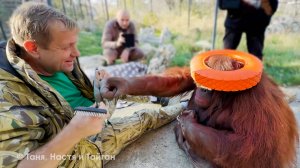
[194,87,213,108]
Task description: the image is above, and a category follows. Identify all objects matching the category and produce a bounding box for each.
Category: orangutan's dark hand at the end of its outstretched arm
[100,77,129,100]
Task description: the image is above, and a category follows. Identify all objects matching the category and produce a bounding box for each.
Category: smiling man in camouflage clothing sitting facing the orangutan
[0,3,182,167]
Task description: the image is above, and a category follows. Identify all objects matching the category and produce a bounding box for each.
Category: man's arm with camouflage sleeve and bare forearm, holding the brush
[0,102,107,167]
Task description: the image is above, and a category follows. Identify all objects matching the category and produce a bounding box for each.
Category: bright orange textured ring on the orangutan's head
[190,49,263,91]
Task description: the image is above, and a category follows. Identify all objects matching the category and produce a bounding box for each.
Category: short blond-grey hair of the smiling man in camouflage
[9,2,78,48]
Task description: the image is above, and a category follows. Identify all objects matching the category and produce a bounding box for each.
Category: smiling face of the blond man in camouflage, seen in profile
[37,22,80,75]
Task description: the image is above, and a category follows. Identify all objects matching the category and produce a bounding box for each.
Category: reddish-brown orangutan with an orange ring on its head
[101,56,298,168]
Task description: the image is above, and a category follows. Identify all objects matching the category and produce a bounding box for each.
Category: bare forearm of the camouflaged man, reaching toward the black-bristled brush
[18,115,105,168]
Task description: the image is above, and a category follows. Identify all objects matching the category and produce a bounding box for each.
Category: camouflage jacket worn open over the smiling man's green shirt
[0,40,102,167]
